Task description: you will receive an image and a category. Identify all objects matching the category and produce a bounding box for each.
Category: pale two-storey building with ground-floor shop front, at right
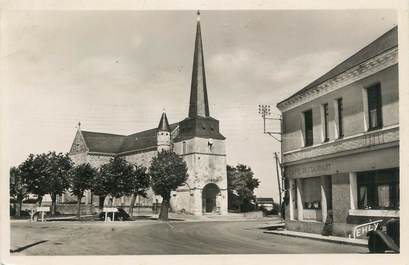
[277,27,399,236]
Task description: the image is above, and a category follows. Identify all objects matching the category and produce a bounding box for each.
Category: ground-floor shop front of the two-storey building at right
[285,144,399,237]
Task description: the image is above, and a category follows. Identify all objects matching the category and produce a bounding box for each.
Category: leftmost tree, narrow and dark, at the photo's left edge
[10,167,27,217]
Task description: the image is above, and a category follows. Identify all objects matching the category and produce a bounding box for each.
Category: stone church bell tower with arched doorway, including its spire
[171,11,227,215]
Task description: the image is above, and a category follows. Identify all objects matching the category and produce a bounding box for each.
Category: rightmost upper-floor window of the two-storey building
[366,84,382,130]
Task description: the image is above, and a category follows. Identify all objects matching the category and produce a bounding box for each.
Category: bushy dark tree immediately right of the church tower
[227,164,260,212]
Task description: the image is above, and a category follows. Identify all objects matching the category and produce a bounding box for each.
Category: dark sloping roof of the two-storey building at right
[277,26,398,105]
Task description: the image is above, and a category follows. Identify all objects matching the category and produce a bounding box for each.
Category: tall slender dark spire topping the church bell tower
[189,11,209,118]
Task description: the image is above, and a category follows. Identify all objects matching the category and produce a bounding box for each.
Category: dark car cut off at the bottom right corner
[368,219,400,253]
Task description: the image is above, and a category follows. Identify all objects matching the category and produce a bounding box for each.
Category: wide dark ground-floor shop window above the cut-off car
[357,168,399,210]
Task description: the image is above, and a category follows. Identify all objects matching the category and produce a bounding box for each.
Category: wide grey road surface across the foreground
[11,221,368,255]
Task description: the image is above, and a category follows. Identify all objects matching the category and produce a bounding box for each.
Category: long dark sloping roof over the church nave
[81,123,178,154]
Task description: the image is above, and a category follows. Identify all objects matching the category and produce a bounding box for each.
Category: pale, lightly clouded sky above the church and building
[1,10,397,201]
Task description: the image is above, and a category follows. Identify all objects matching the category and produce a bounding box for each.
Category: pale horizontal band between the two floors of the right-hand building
[283,125,399,163]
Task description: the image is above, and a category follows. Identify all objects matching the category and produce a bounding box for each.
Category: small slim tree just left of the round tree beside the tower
[127,165,150,218]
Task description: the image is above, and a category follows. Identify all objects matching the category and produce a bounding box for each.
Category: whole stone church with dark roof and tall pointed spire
[69,12,227,215]
